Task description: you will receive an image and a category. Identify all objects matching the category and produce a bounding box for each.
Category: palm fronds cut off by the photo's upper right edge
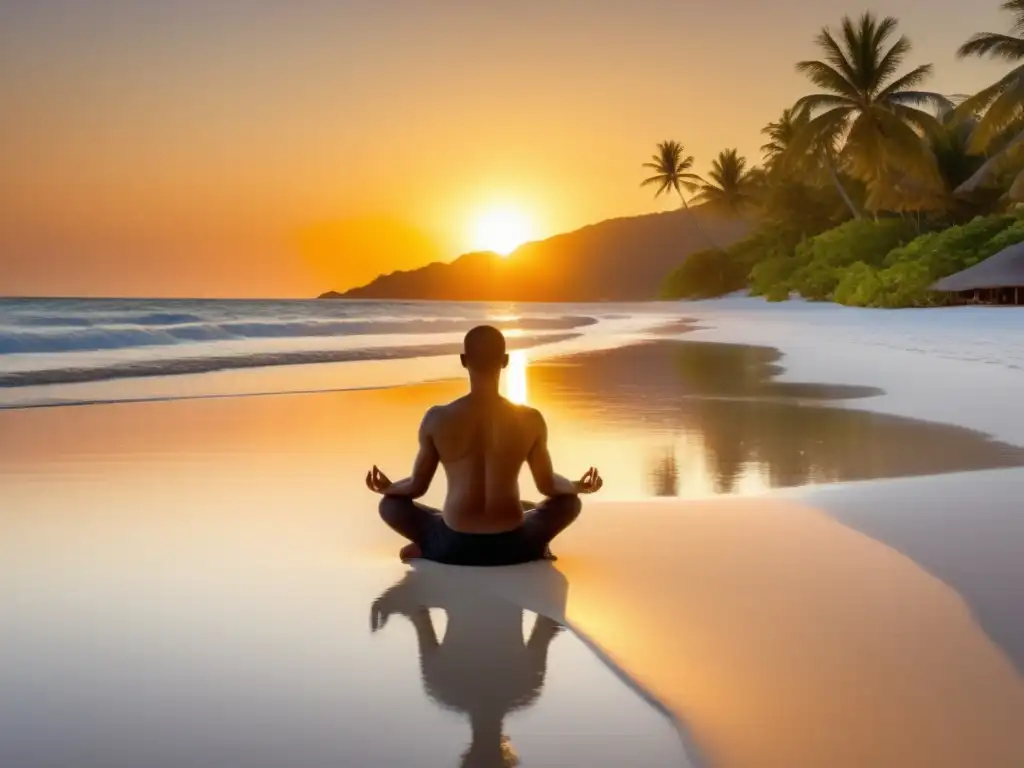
[956,0,1024,191]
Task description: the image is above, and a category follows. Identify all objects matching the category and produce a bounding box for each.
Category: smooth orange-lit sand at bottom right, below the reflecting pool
[426,471,1024,766]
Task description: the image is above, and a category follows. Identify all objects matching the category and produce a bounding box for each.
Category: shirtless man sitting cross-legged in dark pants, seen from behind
[367,326,604,565]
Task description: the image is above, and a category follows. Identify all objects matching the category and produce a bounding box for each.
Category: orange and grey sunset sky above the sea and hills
[0,0,1010,297]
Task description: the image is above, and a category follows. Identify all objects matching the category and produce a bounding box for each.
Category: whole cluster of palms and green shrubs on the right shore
[642,7,1024,307]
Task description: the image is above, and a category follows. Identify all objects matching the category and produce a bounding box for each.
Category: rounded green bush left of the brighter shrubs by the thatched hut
[788,219,915,301]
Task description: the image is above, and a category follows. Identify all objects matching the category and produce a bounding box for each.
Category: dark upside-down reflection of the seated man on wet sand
[370,566,562,768]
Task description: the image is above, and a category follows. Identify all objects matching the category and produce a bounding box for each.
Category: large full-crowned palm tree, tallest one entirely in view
[797,12,949,216]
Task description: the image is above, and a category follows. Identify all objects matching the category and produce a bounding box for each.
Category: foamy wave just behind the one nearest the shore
[0,313,597,354]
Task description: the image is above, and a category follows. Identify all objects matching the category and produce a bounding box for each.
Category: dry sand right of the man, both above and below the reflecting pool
[393,299,1024,768]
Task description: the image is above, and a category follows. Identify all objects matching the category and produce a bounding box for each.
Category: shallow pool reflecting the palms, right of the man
[528,341,1024,497]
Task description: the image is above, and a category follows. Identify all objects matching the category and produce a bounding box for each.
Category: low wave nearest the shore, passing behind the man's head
[0,333,579,387]
